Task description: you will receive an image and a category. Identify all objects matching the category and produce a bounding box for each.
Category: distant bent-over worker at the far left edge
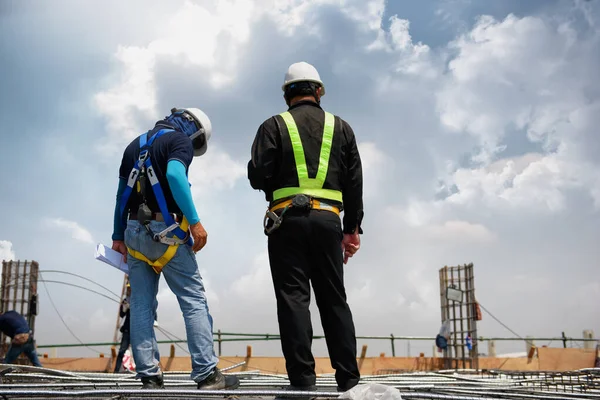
[0,311,43,367]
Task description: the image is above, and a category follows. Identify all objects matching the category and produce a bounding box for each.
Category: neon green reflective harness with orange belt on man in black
[264,111,343,235]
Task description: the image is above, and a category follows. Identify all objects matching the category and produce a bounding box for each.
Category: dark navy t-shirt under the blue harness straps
[119,120,194,214]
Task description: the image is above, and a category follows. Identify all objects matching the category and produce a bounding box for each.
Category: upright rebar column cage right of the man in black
[439,263,479,369]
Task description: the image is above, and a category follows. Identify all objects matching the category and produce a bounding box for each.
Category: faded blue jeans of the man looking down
[125,220,219,382]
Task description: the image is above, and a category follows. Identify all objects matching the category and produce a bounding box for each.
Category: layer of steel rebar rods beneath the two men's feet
[0,364,600,400]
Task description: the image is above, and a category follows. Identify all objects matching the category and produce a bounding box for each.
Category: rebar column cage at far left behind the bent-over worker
[0,261,39,364]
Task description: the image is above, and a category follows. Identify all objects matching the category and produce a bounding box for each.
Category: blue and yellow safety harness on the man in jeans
[120,129,192,274]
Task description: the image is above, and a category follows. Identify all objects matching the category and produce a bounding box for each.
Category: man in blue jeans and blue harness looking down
[113,108,239,390]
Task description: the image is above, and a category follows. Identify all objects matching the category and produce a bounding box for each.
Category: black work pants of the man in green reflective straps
[268,209,360,390]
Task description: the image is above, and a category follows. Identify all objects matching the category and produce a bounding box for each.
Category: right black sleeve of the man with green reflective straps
[341,120,364,234]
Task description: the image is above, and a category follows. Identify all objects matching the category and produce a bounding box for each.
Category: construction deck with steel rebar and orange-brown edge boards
[0,348,600,400]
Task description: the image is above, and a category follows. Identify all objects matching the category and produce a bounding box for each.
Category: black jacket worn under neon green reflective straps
[248,101,364,233]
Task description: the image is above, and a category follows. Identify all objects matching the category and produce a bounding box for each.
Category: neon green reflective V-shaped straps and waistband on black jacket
[273,111,342,202]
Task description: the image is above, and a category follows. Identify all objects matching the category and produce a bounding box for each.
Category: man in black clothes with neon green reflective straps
[248,62,363,391]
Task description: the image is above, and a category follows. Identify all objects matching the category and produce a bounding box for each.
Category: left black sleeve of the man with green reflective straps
[248,117,281,197]
